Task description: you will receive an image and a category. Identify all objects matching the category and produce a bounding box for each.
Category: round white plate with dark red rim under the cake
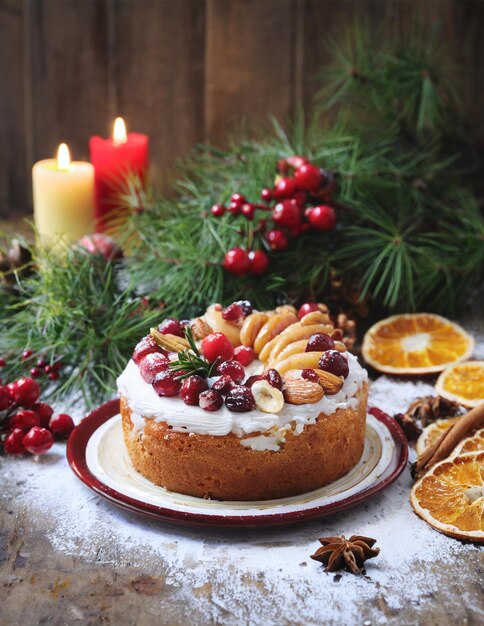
[67,400,408,528]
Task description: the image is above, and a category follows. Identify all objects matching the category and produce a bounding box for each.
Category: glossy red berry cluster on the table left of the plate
[0,378,74,454]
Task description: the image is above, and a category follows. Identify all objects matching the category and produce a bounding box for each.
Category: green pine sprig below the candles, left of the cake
[0,247,160,408]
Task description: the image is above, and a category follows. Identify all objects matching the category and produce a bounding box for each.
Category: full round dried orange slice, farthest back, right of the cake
[362,313,474,375]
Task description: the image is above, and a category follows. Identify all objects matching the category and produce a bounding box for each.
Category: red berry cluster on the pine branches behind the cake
[211,156,336,276]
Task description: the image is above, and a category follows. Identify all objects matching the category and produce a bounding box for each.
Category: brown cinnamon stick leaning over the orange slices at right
[414,404,484,478]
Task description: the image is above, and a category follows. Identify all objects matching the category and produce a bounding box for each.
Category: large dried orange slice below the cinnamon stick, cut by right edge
[410,451,484,543]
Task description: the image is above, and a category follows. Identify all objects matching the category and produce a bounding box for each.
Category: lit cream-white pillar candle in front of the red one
[32,144,94,245]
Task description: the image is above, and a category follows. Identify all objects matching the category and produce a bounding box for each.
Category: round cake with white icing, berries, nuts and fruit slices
[118,301,367,501]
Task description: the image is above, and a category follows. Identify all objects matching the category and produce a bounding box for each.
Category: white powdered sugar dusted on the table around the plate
[0,320,484,626]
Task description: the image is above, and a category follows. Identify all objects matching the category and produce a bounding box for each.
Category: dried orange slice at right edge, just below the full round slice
[435,361,484,408]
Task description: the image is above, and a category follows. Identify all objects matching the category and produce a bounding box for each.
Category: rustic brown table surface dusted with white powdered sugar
[0,320,484,626]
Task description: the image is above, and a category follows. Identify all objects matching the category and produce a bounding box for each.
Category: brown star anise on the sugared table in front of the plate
[311,535,380,574]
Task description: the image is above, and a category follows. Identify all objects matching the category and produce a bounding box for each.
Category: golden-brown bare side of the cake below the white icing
[121,384,368,500]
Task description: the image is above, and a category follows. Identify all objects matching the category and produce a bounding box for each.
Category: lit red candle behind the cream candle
[89,117,149,231]
